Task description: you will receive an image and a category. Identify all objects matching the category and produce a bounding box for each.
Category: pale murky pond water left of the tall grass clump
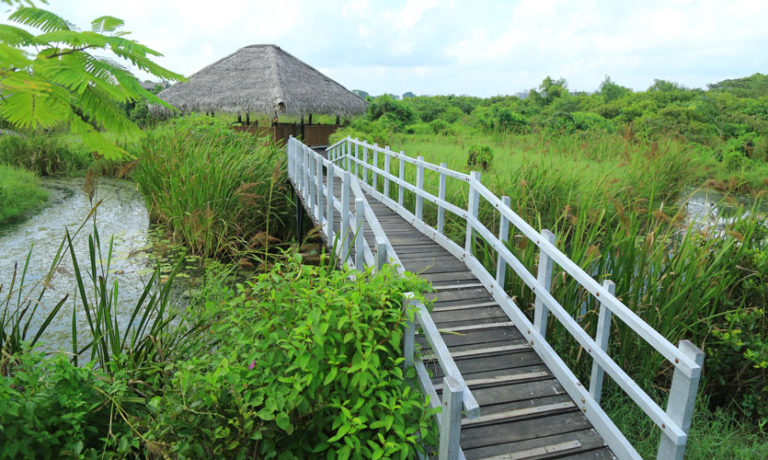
[0,178,184,351]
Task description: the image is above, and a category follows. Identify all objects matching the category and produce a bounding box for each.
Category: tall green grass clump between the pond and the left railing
[132,116,293,259]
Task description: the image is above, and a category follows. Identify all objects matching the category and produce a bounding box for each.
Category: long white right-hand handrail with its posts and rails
[334,137,703,458]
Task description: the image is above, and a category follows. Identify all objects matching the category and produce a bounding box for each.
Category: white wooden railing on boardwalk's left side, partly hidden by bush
[287,137,480,460]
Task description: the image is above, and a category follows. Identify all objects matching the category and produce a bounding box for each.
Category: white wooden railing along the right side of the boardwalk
[320,137,704,460]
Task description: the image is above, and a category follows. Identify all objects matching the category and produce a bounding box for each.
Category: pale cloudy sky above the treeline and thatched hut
[6,0,768,96]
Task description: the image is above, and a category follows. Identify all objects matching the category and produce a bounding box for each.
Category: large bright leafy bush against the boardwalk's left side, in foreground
[149,260,434,459]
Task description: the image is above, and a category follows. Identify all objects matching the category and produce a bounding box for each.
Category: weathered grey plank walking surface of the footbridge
[308,177,616,460]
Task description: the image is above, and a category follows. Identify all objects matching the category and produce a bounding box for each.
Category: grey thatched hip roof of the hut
[154,45,367,115]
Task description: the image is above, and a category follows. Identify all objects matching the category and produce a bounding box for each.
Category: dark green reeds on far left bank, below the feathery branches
[0,134,93,176]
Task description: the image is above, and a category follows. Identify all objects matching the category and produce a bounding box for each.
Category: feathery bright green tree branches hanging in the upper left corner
[0,4,184,158]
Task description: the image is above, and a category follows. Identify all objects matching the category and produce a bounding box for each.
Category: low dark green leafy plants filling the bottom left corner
[0,352,139,459]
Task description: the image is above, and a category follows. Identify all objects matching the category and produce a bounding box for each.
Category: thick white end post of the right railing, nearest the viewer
[656,340,704,460]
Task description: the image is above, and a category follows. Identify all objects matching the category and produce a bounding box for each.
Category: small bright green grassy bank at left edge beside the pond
[0,164,48,223]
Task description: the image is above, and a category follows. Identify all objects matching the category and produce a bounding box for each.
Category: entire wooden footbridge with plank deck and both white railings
[286,138,704,460]
